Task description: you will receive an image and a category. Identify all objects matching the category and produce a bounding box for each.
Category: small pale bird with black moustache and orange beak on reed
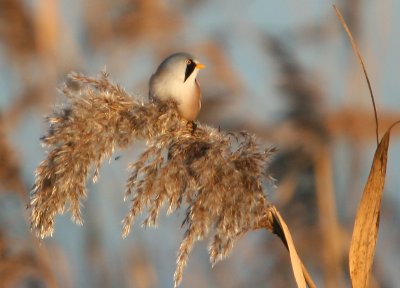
[149,52,205,123]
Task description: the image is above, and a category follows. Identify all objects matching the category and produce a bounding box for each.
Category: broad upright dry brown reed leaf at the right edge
[349,129,390,288]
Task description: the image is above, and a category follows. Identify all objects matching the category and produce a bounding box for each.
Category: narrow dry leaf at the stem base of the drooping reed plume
[271,207,307,288]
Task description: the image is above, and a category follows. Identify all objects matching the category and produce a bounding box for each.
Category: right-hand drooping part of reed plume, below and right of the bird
[123,126,269,285]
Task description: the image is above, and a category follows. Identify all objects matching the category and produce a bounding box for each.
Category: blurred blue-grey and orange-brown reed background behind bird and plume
[0,0,400,288]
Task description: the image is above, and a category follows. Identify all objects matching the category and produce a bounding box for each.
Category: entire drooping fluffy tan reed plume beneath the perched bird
[31,73,273,286]
